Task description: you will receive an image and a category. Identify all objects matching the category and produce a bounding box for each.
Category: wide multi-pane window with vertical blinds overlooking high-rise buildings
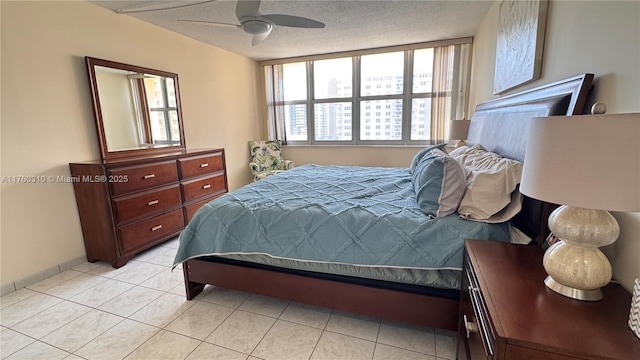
[265,39,470,145]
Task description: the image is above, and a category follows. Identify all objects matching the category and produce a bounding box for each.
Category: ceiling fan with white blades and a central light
[178,0,324,46]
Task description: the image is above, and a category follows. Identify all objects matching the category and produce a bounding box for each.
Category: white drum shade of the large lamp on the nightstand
[520,113,640,211]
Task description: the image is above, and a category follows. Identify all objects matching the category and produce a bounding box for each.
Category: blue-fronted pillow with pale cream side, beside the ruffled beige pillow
[411,148,466,218]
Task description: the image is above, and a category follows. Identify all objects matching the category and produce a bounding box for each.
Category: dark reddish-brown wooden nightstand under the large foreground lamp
[458,240,640,360]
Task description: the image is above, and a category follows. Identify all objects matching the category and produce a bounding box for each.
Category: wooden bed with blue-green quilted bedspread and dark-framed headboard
[175,74,593,330]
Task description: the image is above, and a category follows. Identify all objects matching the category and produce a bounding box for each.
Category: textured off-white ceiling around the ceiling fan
[91,0,493,60]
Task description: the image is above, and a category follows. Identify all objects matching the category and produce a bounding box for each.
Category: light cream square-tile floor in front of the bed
[0,239,455,360]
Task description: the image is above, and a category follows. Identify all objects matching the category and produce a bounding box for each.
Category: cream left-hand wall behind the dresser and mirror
[0,1,262,285]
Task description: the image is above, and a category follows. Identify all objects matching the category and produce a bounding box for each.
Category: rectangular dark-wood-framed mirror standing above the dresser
[85,57,185,160]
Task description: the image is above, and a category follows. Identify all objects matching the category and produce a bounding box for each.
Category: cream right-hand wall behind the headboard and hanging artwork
[469,0,640,290]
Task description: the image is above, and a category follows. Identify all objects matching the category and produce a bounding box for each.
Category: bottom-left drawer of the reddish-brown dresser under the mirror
[119,208,184,253]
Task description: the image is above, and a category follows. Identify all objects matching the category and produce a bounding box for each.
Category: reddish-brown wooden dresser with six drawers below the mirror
[69,149,228,268]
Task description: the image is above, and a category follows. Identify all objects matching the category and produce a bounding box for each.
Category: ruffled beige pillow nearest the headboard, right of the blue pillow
[449,145,522,223]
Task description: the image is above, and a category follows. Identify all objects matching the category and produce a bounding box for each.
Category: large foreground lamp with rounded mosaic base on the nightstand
[520,113,640,301]
